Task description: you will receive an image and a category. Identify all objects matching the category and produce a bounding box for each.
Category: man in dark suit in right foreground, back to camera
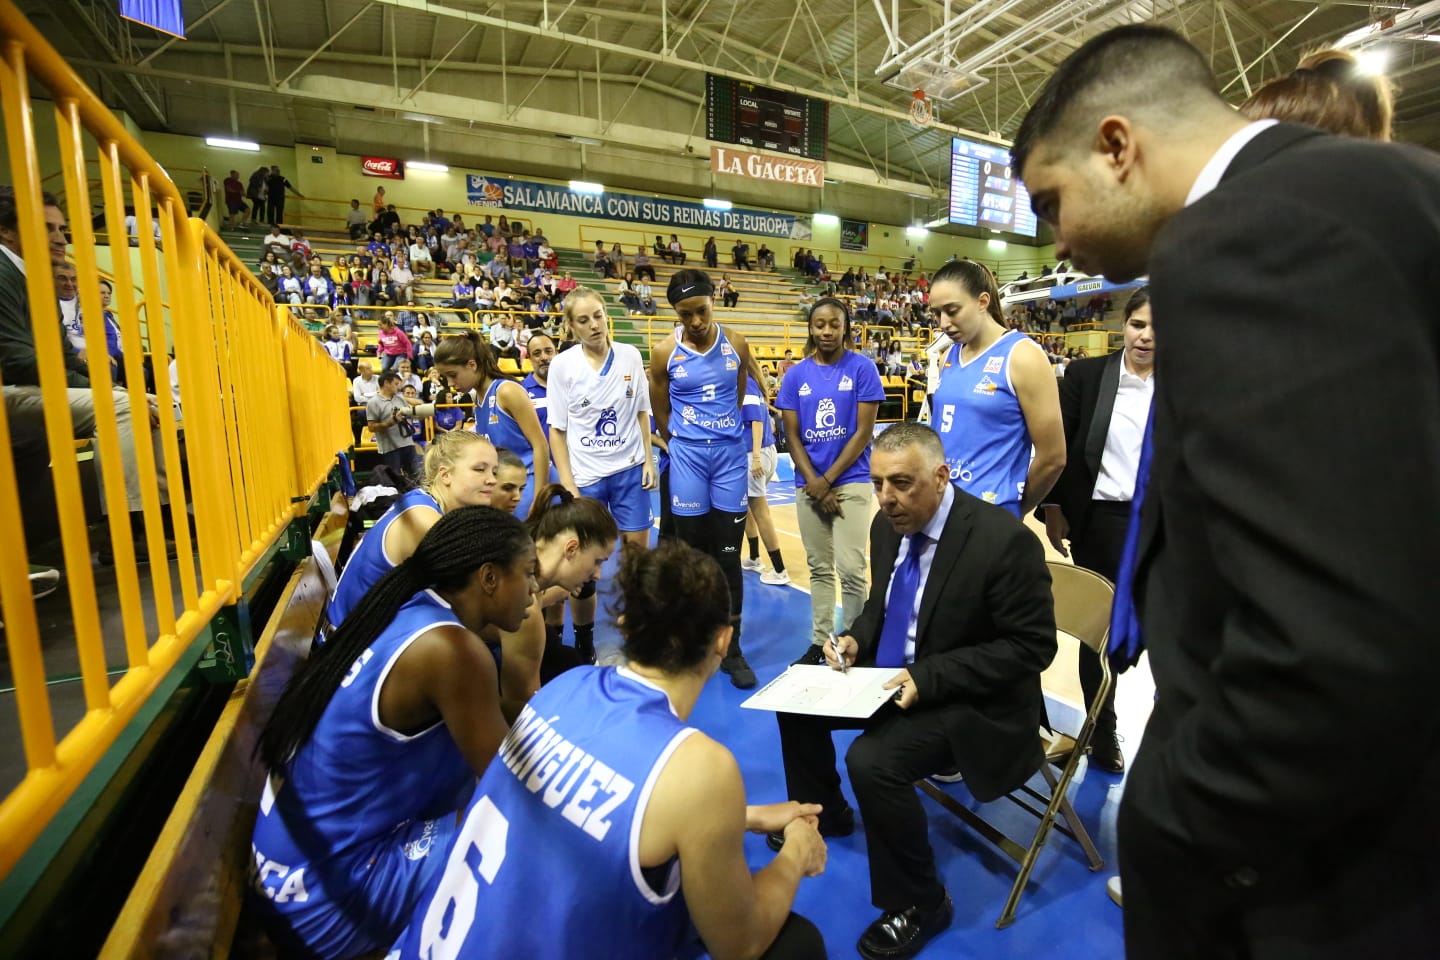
[1012,24,1440,960]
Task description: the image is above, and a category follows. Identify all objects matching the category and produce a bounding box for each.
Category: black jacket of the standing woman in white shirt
[1037,350,1125,540]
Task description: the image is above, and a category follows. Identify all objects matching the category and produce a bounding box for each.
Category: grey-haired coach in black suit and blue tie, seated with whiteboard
[770,423,1056,960]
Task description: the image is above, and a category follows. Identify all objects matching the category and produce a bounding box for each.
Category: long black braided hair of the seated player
[256,507,530,770]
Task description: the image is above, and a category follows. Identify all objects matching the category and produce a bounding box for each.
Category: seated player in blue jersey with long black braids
[252,507,536,957]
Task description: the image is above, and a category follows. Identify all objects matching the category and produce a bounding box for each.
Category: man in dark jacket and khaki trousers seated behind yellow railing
[0,186,173,563]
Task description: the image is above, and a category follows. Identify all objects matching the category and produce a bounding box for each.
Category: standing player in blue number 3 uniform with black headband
[649,271,765,689]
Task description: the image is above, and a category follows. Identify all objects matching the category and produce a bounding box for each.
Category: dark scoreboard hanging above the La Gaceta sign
[706,73,829,160]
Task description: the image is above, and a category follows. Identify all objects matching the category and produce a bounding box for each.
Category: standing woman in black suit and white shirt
[1035,286,1155,773]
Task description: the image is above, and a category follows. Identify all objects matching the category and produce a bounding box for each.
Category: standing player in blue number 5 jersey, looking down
[930,261,1066,517]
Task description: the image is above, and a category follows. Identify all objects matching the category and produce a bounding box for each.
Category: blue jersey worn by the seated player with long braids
[251,590,475,957]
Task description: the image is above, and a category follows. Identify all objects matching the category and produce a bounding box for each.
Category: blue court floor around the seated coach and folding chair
[596,571,1138,960]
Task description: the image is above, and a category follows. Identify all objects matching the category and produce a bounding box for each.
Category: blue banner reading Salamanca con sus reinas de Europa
[465,173,811,240]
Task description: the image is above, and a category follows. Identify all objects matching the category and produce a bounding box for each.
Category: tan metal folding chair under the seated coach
[917,560,1115,928]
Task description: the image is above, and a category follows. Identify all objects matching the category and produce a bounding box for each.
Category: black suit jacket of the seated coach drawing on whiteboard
[847,488,1056,800]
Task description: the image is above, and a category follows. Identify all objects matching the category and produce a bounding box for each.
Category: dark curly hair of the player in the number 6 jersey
[611,540,730,674]
